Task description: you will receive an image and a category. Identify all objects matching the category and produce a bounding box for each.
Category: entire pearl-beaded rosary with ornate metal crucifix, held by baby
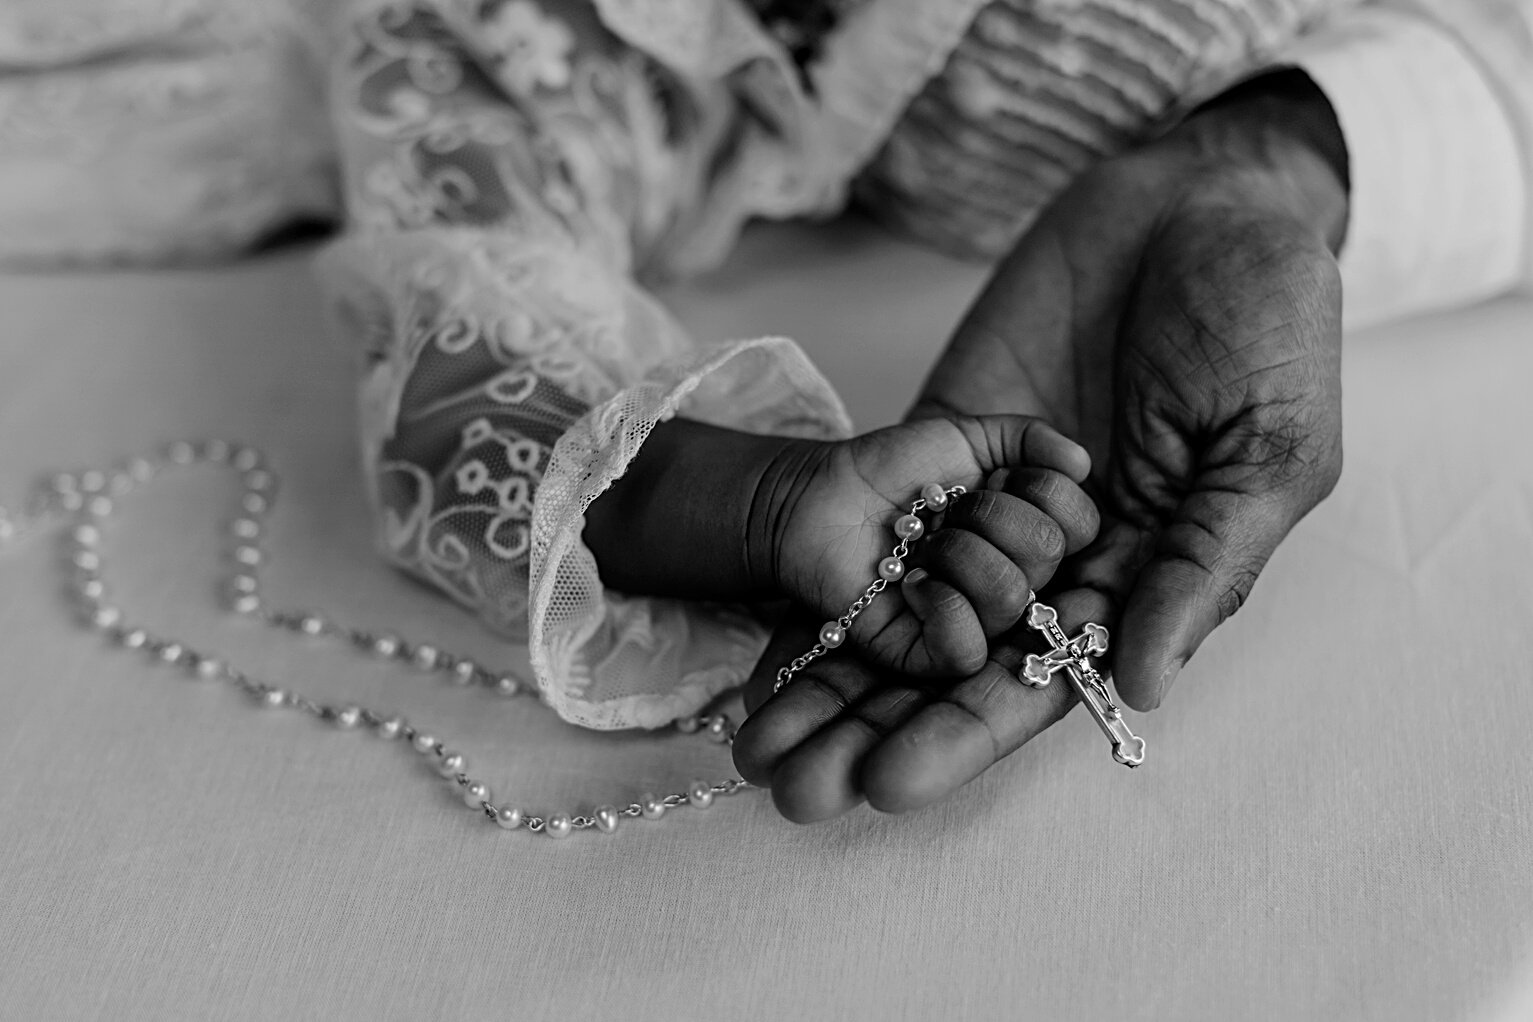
[0,440,1145,838]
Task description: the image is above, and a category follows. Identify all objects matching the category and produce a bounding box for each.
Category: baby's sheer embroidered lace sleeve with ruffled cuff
[320,0,849,728]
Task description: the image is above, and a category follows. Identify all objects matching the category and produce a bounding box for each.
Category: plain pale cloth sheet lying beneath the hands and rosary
[0,228,1533,1022]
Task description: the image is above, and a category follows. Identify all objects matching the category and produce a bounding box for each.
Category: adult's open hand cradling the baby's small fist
[734,72,1346,820]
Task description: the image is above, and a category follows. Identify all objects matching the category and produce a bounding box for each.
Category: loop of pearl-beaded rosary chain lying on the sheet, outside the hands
[0,440,751,838]
